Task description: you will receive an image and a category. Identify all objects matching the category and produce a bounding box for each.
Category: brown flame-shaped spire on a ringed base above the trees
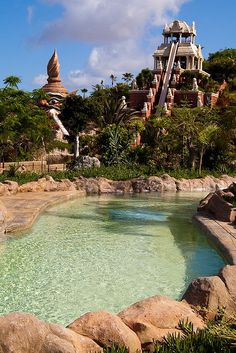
[42,50,68,96]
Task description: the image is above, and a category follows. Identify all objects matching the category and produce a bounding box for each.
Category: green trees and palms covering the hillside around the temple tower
[0,49,236,178]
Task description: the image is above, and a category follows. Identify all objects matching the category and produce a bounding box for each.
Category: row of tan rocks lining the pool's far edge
[0,174,236,196]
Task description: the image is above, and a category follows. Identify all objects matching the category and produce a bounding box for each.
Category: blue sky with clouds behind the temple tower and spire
[0,0,236,91]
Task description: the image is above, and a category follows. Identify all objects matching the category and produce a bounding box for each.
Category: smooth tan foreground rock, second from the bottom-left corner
[68,311,141,353]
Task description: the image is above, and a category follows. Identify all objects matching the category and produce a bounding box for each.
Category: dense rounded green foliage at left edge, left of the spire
[0,88,53,161]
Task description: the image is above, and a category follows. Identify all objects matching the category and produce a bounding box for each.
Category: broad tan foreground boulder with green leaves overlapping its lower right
[118,295,205,350]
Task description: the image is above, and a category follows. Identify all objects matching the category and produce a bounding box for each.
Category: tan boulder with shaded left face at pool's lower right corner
[182,276,236,319]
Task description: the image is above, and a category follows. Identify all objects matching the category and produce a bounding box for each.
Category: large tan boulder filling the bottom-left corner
[0,313,101,353]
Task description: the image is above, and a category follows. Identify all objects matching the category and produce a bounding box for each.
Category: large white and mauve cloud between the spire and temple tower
[38,0,191,89]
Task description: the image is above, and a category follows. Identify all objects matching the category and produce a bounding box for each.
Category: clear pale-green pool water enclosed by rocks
[0,193,224,324]
